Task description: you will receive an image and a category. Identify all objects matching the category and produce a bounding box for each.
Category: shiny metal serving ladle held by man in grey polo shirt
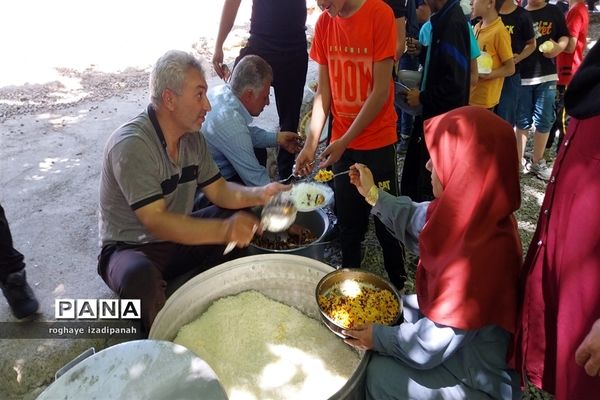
[223,192,298,255]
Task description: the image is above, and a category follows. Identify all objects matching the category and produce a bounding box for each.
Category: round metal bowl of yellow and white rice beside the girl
[315,268,402,338]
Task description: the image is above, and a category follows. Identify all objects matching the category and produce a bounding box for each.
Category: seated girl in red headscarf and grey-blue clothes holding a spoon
[345,107,521,400]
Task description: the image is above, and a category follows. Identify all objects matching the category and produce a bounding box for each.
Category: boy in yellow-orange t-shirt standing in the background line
[469,0,515,109]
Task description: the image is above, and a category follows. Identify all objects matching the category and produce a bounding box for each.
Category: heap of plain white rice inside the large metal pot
[175,291,360,400]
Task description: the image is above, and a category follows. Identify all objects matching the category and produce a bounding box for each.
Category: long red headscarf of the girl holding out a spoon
[416,106,521,332]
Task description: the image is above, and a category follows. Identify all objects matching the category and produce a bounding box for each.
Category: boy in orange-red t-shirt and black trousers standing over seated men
[296,0,406,290]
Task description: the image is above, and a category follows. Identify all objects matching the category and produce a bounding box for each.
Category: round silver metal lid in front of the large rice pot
[38,340,227,400]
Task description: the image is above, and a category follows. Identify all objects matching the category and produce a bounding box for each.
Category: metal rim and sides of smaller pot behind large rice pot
[248,208,329,261]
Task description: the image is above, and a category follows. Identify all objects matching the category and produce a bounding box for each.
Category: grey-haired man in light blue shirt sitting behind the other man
[201,55,300,186]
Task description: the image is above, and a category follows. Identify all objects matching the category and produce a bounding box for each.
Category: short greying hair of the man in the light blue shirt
[230,54,273,97]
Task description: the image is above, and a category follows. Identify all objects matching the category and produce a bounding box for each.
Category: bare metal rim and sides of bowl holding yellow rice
[315,268,402,338]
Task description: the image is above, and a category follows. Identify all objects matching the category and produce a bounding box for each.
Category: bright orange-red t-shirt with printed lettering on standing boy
[310,0,397,150]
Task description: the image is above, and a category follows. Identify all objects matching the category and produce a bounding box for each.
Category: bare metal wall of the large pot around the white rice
[150,254,369,400]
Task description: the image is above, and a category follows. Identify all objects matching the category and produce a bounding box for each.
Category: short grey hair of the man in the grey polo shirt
[150,50,206,107]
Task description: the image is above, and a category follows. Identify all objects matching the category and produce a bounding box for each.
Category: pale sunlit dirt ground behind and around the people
[0,0,600,399]
